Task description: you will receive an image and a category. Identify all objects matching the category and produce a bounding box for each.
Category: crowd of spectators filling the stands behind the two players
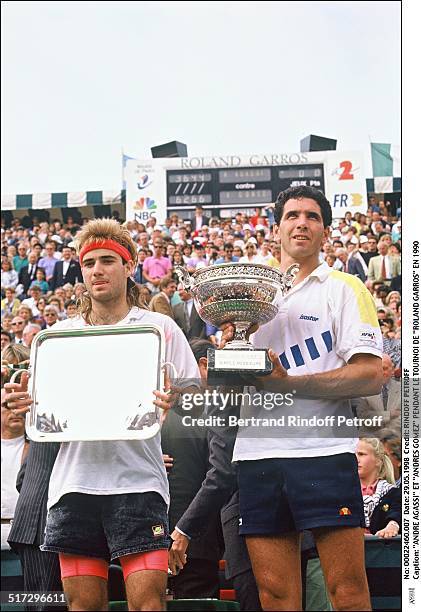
[1,198,402,608]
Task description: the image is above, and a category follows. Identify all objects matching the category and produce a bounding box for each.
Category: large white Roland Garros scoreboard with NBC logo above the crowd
[125,151,367,223]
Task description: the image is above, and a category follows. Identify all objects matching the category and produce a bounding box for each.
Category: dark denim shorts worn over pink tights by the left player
[41,492,171,560]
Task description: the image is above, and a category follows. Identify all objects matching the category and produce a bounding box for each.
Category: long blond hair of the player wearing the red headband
[74,218,145,320]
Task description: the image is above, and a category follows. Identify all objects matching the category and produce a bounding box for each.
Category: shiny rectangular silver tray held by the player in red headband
[26,324,166,442]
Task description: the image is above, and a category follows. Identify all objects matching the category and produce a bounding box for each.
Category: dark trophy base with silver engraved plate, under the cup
[207,348,273,386]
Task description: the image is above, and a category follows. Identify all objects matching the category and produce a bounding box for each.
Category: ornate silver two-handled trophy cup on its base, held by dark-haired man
[175,263,299,384]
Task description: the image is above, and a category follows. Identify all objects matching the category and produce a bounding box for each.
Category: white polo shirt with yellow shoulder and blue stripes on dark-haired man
[233,263,383,461]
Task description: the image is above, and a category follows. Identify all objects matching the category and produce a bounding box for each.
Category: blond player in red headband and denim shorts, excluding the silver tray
[5,219,199,610]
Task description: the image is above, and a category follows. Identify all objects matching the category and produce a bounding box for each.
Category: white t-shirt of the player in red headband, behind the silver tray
[44,307,199,508]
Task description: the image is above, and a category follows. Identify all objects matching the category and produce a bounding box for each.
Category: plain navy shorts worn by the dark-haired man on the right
[238,453,365,535]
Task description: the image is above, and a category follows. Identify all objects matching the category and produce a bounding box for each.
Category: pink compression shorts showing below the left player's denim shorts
[59,549,168,580]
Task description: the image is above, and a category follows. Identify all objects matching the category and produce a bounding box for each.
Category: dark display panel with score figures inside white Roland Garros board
[167,164,325,210]
